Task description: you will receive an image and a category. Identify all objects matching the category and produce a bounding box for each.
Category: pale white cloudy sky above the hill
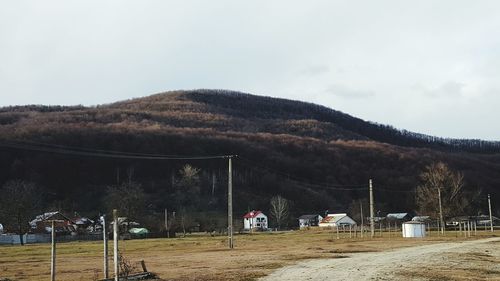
[0,0,500,140]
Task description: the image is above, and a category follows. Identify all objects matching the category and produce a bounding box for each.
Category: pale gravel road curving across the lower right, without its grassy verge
[260,237,500,281]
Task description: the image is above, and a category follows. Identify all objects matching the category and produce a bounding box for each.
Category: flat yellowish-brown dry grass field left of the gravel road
[0,230,498,281]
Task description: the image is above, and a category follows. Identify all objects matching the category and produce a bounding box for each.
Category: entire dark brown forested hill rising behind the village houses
[0,90,500,230]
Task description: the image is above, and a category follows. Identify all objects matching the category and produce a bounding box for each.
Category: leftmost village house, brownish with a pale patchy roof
[29,212,76,234]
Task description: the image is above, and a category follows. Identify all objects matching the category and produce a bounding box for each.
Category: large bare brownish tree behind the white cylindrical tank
[416,162,478,223]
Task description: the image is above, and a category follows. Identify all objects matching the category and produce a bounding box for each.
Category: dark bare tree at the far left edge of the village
[0,180,42,245]
